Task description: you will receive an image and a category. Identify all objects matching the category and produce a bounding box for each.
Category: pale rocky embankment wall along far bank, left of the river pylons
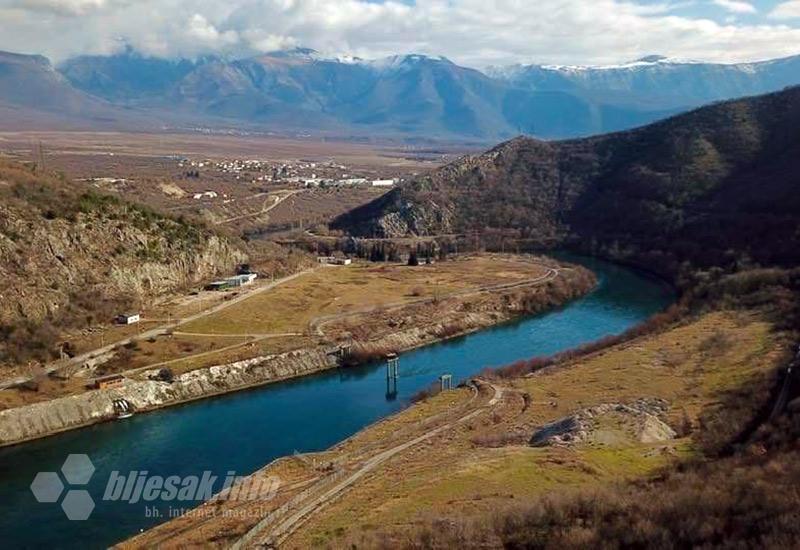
[0,349,337,446]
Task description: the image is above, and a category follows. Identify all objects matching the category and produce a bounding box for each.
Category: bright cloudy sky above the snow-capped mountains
[0,0,800,68]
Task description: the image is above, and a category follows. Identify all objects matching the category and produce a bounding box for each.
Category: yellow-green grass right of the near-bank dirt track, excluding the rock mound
[280,312,783,548]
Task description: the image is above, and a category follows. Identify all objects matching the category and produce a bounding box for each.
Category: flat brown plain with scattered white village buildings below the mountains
[0,132,446,234]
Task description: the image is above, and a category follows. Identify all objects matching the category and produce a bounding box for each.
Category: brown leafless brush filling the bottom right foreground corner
[354,390,800,549]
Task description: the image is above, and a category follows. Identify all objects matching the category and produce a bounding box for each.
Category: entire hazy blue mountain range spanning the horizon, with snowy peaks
[0,48,800,142]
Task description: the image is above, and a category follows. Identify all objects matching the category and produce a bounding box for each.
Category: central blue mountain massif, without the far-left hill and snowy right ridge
[60,48,664,140]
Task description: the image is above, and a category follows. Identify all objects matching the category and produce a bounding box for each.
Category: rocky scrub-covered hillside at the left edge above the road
[0,162,246,362]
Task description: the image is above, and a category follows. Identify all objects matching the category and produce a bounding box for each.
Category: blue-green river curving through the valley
[0,259,674,548]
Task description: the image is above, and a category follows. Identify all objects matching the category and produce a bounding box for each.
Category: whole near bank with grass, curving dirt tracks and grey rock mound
[122,311,788,548]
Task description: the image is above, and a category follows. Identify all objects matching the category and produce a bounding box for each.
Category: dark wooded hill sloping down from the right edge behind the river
[335,88,800,274]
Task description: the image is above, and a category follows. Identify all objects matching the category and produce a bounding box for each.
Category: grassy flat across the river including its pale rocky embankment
[0,255,594,444]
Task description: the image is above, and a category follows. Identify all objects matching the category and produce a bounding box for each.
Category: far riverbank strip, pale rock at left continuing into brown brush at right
[0,254,596,446]
